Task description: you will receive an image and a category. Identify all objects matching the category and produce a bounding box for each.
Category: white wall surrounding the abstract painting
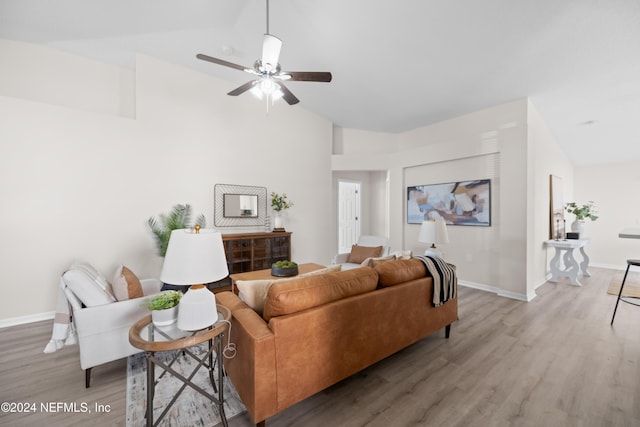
[332,99,572,300]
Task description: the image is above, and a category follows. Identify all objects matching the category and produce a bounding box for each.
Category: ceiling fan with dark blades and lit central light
[196,0,331,105]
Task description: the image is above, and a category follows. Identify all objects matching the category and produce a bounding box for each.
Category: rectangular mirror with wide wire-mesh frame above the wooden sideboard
[213,184,267,227]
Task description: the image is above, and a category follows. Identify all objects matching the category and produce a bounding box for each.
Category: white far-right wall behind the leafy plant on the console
[566,160,640,269]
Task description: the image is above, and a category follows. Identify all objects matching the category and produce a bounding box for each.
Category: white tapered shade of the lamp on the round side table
[160,228,229,285]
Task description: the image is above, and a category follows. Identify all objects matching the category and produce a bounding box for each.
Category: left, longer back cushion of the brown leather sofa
[262,267,378,321]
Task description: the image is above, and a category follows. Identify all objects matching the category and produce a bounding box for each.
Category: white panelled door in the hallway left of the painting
[338,181,360,254]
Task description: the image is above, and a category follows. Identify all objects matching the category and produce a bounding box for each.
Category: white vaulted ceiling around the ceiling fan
[0,0,640,165]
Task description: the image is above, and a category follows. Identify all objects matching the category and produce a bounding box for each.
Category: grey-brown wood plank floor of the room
[0,268,640,427]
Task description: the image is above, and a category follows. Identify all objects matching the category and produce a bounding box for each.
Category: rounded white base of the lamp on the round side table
[178,285,218,331]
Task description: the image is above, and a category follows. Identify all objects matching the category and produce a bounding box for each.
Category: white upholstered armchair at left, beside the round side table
[61,269,162,387]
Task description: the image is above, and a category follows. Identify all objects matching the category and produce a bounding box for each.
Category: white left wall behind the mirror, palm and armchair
[0,41,334,324]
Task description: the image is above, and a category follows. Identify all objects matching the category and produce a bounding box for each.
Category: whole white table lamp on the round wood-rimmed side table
[160,225,229,331]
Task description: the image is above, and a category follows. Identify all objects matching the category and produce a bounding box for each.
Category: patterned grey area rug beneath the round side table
[127,343,246,427]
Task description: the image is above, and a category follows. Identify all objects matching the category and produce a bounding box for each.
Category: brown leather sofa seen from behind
[217,259,458,425]
